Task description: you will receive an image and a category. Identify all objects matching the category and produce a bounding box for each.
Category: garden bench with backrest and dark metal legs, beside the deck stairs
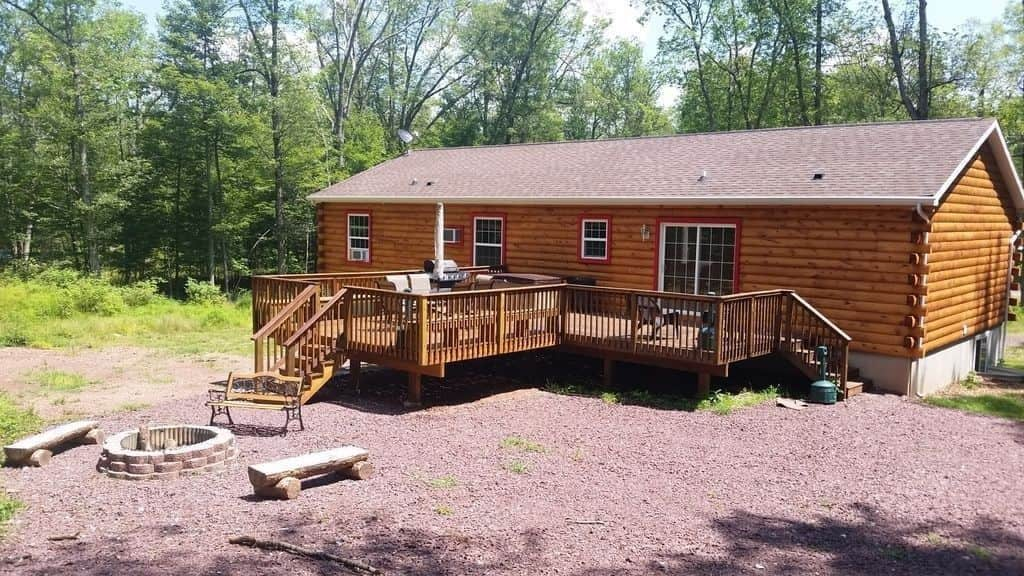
[206,372,306,431]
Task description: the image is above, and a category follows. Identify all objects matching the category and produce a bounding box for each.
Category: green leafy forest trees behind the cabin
[0,0,1024,287]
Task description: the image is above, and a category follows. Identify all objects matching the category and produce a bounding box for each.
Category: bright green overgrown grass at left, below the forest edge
[0,276,252,355]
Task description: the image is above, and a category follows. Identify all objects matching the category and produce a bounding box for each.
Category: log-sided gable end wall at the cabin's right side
[925,147,1017,352]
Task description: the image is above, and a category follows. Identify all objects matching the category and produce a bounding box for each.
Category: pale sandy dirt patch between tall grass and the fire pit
[0,347,252,420]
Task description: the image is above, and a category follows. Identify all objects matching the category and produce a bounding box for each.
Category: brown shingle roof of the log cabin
[310,119,1016,204]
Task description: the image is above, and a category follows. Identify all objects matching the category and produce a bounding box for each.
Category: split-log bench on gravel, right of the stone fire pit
[249,446,374,500]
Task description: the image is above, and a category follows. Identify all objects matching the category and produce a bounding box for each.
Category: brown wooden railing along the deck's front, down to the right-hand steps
[345,285,850,388]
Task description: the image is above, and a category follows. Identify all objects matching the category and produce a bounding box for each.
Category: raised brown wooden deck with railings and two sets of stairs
[253,270,850,402]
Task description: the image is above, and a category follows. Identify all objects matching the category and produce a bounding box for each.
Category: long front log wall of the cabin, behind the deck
[317,203,928,357]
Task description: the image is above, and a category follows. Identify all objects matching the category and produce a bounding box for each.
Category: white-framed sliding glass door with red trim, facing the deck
[660,223,736,295]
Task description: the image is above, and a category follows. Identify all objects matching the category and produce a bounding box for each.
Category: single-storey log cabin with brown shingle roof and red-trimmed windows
[294,119,1024,395]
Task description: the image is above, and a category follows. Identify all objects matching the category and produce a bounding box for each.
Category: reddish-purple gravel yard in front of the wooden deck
[0,358,1024,576]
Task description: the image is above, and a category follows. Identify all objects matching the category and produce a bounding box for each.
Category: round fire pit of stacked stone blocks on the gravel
[96,425,239,480]
